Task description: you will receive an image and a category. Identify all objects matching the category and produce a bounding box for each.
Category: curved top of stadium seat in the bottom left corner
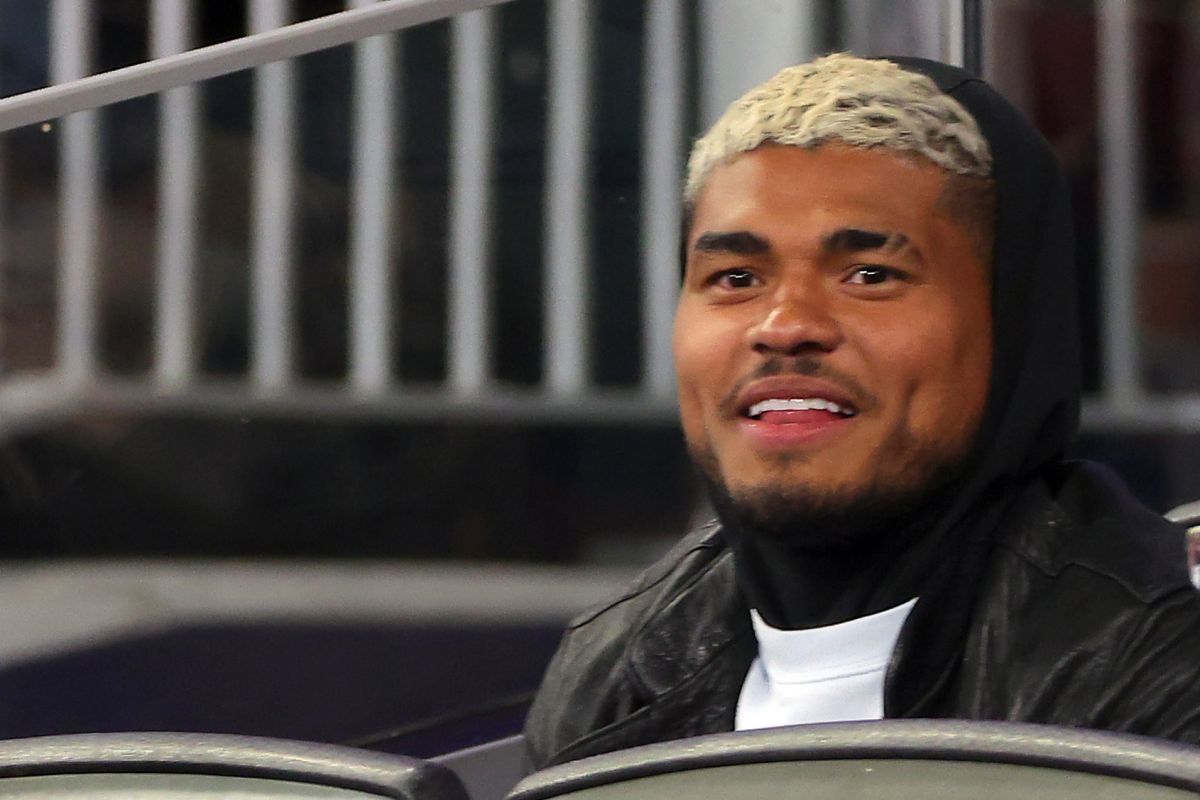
[0,733,467,800]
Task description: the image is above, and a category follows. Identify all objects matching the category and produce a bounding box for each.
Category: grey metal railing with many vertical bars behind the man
[0,0,1200,431]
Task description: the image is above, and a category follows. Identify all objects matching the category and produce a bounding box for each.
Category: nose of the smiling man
[746,284,842,356]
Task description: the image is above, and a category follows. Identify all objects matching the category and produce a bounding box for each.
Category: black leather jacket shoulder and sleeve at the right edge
[959,463,1200,742]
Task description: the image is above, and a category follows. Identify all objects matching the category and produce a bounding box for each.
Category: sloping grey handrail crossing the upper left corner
[0,0,509,132]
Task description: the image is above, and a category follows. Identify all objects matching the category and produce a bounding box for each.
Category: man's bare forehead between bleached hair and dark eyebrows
[689,144,946,245]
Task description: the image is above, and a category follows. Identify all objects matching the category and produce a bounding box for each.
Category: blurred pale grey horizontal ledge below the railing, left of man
[0,556,638,662]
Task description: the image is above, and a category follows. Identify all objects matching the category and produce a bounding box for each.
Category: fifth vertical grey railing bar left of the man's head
[250,0,295,391]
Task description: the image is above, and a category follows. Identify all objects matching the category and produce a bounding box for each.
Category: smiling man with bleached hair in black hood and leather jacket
[526,55,1200,768]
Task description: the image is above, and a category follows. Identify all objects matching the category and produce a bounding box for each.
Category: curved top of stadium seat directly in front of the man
[509,720,1200,800]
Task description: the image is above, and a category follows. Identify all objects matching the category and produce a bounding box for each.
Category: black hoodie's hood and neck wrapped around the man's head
[719,58,1080,700]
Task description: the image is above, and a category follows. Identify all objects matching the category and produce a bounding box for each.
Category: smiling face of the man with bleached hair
[674,145,992,532]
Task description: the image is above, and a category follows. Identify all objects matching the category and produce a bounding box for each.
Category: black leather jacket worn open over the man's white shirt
[526,464,1200,768]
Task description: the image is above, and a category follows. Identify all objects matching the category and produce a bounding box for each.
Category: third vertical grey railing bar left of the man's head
[449,8,494,396]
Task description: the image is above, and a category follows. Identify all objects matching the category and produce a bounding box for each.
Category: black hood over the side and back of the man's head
[888,58,1081,520]
